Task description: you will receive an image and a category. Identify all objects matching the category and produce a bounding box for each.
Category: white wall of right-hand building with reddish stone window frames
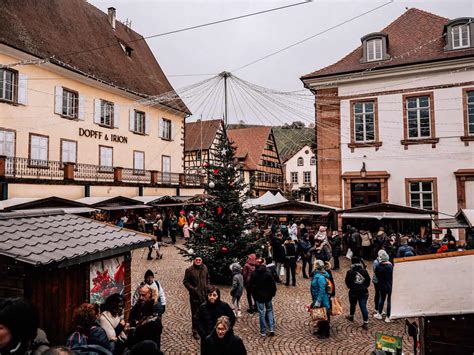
[338,65,474,215]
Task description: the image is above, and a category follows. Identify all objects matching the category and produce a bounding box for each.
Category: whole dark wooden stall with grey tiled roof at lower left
[0,210,153,344]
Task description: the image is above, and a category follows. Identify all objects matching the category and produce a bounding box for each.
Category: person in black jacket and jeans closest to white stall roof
[374,252,393,323]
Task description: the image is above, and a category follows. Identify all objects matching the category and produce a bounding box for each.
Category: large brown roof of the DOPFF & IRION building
[0,0,189,113]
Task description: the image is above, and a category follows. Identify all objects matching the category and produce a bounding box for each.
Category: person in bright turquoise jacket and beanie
[310,260,334,339]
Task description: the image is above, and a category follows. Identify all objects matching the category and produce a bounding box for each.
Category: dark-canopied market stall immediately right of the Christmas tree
[256,201,337,230]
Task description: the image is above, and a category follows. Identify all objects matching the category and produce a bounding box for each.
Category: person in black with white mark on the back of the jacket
[346,256,370,330]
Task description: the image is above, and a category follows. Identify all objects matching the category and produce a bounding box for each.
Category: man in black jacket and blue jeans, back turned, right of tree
[250,259,276,336]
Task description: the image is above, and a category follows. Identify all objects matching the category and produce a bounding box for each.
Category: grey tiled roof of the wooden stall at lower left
[0,213,150,266]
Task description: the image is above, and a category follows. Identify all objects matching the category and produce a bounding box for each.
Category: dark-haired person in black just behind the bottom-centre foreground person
[196,285,235,348]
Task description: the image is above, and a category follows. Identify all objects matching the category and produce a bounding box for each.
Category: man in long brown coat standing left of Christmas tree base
[183,256,209,339]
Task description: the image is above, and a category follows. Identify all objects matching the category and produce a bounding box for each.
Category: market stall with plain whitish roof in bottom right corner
[390,250,474,355]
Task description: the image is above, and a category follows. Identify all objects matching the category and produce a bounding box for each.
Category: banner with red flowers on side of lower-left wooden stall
[90,256,125,304]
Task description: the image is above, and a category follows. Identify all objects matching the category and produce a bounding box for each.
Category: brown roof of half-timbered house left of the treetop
[184,120,223,152]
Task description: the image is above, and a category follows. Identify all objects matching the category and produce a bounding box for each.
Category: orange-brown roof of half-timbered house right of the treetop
[227,127,272,170]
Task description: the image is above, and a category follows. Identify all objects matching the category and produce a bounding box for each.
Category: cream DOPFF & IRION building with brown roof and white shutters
[0,0,199,199]
